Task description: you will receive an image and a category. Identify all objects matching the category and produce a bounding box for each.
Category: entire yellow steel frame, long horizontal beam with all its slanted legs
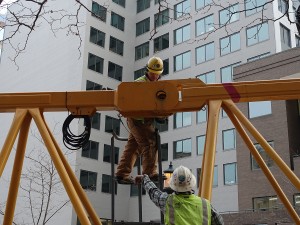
[0,78,300,225]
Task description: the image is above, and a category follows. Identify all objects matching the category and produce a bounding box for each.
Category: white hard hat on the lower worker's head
[170,166,196,192]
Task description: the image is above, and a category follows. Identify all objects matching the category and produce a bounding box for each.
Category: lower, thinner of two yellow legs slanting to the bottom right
[224,101,300,224]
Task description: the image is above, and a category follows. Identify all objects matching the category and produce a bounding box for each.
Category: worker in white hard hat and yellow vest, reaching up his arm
[135,166,224,225]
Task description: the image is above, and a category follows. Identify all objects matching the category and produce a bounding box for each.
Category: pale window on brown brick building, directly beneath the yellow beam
[249,101,272,119]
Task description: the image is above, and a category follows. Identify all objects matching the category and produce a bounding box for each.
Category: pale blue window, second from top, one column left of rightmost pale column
[220,33,241,55]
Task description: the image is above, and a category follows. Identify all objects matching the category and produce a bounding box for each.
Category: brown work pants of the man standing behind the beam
[116,118,158,178]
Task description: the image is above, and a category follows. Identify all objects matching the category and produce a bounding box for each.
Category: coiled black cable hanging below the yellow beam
[62,114,91,150]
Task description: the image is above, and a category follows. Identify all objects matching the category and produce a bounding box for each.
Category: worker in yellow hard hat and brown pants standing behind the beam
[115,57,163,184]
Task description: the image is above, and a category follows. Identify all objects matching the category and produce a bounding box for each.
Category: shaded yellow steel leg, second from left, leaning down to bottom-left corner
[3,114,31,224]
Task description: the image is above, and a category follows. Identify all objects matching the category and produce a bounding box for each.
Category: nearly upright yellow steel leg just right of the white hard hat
[199,100,222,200]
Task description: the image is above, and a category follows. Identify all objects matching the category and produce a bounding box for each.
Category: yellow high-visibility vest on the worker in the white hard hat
[165,194,211,225]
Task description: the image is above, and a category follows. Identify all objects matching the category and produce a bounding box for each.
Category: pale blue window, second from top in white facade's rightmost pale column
[246,23,269,46]
